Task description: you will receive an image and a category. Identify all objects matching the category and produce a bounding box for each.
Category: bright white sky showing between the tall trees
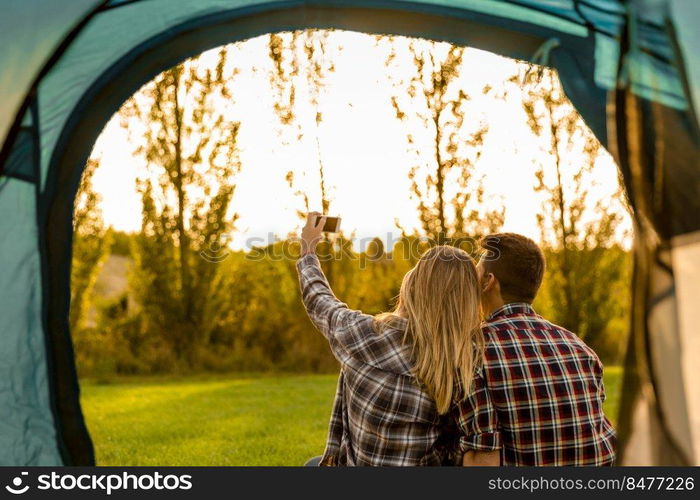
[86,31,630,248]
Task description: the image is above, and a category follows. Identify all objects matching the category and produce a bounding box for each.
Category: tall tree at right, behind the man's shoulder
[522,70,630,359]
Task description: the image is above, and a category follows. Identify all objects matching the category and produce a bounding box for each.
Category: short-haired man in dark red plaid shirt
[459,233,615,466]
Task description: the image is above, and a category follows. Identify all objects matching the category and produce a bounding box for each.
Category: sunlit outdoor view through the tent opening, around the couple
[68,29,632,465]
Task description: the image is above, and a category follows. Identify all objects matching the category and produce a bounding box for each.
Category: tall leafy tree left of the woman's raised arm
[120,47,241,367]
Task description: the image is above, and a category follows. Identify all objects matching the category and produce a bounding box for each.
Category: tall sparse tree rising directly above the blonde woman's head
[387,38,505,242]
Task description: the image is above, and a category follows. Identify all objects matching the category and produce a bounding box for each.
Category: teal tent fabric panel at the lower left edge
[0,179,62,465]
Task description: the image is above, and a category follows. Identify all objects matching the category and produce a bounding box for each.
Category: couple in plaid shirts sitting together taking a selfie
[297,213,615,466]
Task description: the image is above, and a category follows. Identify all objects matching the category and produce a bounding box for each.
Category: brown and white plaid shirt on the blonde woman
[297,255,497,466]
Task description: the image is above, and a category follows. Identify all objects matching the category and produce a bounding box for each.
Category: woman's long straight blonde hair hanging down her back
[376,246,484,414]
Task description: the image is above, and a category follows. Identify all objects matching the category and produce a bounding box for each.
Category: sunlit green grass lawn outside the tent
[82,367,621,466]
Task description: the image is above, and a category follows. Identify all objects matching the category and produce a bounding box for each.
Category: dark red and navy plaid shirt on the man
[459,303,615,466]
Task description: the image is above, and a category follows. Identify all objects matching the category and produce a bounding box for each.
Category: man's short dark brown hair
[479,233,545,303]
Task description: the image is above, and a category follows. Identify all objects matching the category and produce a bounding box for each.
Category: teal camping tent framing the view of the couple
[0,0,700,465]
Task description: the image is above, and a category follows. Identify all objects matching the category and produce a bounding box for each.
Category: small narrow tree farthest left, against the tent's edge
[69,158,110,335]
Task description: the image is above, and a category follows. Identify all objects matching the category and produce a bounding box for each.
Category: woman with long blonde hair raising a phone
[297,213,500,466]
